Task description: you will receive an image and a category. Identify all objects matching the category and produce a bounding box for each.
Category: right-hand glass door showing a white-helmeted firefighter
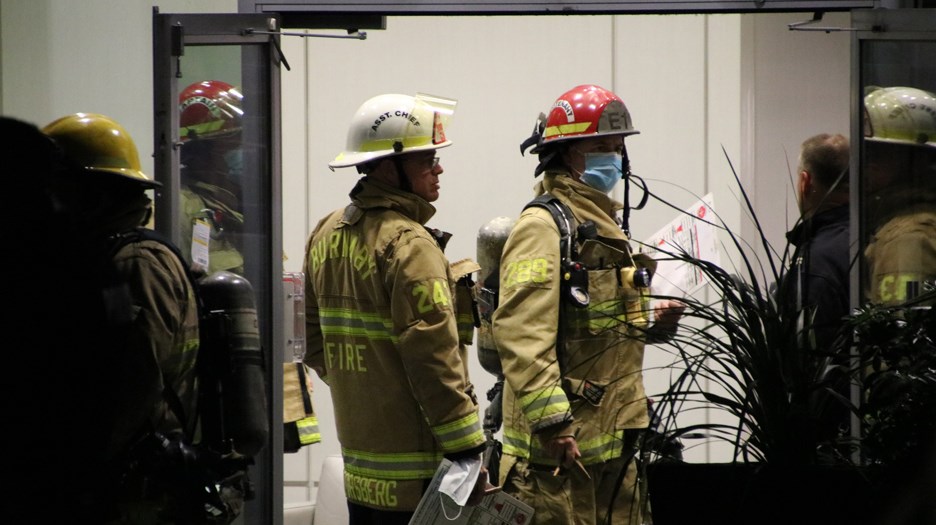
[851,9,936,307]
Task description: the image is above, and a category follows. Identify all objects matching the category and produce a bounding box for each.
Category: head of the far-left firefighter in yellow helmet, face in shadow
[42,113,161,227]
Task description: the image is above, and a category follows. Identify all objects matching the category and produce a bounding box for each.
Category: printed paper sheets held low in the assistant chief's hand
[410,459,533,525]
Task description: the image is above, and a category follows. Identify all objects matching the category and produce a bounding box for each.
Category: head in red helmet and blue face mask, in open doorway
[520,84,640,187]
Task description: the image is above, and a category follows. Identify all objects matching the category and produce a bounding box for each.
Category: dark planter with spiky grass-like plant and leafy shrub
[632,154,936,525]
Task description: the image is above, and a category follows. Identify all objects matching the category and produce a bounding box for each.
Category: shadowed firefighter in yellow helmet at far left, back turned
[42,113,199,523]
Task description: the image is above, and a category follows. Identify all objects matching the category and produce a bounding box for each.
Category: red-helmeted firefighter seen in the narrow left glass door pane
[179,80,244,274]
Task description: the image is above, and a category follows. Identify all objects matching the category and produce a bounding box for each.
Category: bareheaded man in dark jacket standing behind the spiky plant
[778,133,852,458]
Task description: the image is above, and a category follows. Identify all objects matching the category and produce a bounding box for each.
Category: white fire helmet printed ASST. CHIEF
[328,94,456,170]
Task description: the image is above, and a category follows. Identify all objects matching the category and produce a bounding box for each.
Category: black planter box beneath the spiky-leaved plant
[647,462,873,525]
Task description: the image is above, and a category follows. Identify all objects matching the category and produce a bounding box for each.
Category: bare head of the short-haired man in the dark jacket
[796,133,850,216]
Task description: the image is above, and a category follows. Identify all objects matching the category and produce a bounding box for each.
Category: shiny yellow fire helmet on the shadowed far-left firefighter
[42,113,162,188]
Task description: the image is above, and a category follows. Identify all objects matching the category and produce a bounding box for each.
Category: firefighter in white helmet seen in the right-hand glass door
[864,87,936,304]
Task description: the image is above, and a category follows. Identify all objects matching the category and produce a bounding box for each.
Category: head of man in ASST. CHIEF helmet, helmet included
[328,94,455,202]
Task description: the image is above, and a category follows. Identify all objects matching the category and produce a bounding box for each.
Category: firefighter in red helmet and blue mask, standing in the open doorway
[493,85,684,524]
